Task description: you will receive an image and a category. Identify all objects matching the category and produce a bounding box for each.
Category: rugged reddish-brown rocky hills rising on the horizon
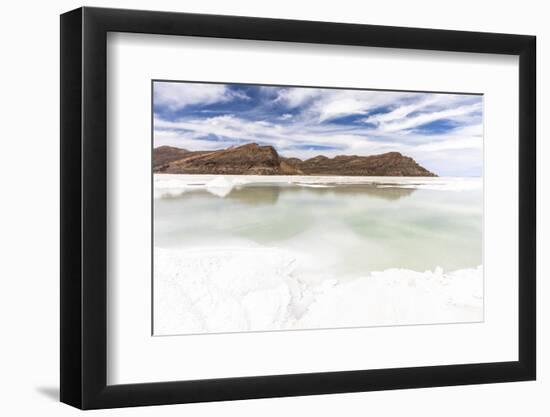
[153,143,436,177]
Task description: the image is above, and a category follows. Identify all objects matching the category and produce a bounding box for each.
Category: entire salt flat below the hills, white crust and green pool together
[153,174,483,335]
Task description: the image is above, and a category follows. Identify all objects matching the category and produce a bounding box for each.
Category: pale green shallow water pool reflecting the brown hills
[154,184,483,276]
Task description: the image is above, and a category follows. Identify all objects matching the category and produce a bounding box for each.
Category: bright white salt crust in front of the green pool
[154,247,483,335]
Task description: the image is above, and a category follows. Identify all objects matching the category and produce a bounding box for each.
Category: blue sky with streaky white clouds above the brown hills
[153,81,483,177]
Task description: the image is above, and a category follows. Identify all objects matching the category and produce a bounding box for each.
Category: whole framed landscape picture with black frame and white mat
[61,7,536,409]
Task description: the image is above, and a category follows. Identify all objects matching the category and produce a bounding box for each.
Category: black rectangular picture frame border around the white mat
[60,7,536,409]
